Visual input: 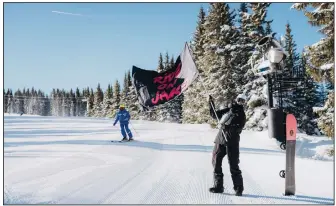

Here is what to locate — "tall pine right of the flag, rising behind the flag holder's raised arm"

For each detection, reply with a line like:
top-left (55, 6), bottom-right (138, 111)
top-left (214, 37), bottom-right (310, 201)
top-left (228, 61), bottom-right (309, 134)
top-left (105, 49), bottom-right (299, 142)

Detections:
top-left (201, 3), bottom-right (239, 126)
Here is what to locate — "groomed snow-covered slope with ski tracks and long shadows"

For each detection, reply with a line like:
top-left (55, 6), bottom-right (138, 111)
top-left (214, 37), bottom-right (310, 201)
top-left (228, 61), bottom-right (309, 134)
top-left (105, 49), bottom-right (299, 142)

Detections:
top-left (4, 115), bottom-right (334, 204)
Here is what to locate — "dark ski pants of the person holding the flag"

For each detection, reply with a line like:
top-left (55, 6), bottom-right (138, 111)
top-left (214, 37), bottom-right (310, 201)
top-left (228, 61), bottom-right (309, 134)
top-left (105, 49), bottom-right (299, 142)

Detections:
top-left (212, 141), bottom-right (244, 190)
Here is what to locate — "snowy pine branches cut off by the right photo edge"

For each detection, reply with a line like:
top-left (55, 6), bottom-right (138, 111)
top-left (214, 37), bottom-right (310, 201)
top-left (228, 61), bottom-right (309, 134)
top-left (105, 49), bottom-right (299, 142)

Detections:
top-left (292, 2), bottom-right (335, 138)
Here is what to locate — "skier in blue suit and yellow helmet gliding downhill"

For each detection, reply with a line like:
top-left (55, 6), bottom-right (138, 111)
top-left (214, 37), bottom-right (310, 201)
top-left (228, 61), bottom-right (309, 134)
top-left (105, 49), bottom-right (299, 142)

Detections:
top-left (113, 104), bottom-right (133, 141)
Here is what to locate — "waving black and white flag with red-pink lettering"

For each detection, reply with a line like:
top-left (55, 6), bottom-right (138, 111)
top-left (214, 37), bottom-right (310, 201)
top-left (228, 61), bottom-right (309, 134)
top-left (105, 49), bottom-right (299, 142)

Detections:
top-left (132, 43), bottom-right (198, 110)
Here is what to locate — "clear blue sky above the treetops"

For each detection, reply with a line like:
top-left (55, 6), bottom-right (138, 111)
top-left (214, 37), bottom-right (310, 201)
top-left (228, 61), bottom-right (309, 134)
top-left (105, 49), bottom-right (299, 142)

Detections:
top-left (4, 3), bottom-right (322, 94)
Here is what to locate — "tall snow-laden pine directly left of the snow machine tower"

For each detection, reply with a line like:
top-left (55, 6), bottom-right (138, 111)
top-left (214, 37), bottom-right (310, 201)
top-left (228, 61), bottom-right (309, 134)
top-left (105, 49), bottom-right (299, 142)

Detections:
top-left (240, 3), bottom-right (271, 131)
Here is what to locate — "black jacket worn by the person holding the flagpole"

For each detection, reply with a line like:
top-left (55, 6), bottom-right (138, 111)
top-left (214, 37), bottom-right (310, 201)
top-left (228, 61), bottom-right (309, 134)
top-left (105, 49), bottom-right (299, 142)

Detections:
top-left (209, 99), bottom-right (246, 144)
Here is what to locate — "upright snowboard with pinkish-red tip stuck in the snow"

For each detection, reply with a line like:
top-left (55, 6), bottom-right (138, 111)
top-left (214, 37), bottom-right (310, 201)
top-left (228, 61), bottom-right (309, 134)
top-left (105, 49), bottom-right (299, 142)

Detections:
top-left (283, 114), bottom-right (297, 196)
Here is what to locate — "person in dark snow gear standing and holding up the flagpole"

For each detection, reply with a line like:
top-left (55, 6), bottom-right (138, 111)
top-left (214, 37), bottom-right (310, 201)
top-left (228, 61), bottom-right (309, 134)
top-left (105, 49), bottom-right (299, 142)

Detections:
top-left (209, 94), bottom-right (246, 196)
